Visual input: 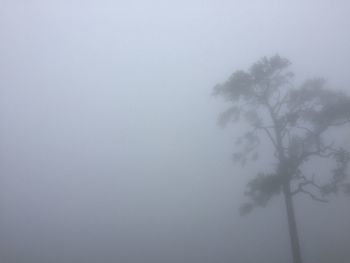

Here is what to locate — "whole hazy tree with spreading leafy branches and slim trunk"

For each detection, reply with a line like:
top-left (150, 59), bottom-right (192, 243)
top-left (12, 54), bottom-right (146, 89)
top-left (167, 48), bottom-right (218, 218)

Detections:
top-left (213, 55), bottom-right (350, 263)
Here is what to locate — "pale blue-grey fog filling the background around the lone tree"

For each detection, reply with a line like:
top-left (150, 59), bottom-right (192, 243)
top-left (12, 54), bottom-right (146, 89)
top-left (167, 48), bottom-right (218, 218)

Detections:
top-left (0, 0), bottom-right (350, 263)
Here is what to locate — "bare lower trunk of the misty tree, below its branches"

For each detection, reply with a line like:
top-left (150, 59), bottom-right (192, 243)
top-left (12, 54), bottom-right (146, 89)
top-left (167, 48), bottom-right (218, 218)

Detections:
top-left (283, 182), bottom-right (302, 263)
